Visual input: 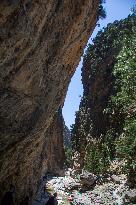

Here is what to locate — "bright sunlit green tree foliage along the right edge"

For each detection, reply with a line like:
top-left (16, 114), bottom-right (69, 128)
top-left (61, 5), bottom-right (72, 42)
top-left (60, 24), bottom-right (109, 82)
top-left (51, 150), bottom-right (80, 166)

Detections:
top-left (112, 33), bottom-right (136, 181)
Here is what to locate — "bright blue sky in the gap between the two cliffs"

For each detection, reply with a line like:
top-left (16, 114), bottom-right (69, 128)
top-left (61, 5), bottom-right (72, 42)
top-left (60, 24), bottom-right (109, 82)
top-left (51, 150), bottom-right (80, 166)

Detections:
top-left (63, 0), bottom-right (136, 128)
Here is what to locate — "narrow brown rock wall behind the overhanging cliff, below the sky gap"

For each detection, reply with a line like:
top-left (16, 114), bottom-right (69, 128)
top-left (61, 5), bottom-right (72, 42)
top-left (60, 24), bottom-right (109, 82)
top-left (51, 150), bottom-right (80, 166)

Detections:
top-left (43, 109), bottom-right (65, 175)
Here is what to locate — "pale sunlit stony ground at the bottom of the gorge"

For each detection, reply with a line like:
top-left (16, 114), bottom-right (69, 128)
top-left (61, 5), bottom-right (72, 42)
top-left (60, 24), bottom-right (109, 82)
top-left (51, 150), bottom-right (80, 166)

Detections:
top-left (33, 171), bottom-right (136, 205)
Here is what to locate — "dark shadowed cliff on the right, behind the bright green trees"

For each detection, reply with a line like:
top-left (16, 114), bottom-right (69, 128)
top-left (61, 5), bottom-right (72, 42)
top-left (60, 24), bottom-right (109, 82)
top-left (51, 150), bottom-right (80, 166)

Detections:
top-left (72, 16), bottom-right (136, 172)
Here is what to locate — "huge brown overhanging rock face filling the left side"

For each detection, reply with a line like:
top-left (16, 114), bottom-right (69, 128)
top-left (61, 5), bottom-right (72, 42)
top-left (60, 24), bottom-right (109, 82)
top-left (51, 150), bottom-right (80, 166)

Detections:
top-left (0, 0), bottom-right (99, 202)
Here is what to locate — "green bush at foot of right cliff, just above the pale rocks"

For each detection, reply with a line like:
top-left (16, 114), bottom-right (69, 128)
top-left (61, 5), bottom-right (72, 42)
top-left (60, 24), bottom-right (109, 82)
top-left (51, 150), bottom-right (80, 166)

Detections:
top-left (85, 129), bottom-right (118, 174)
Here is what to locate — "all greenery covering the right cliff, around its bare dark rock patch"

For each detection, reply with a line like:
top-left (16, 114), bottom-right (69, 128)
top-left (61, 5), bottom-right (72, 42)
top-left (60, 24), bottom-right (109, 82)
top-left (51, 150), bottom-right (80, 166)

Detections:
top-left (72, 13), bottom-right (136, 179)
